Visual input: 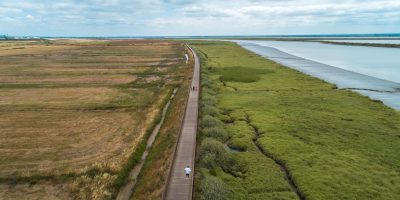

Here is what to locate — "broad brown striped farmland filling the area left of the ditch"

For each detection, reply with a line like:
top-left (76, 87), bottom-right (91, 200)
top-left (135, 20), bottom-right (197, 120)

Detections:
top-left (0, 40), bottom-right (187, 199)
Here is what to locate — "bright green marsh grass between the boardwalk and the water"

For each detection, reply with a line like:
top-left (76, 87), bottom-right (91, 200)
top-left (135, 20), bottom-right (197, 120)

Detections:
top-left (192, 42), bottom-right (400, 199)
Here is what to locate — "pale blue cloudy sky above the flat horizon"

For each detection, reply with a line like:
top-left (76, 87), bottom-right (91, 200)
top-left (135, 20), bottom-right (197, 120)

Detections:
top-left (0, 0), bottom-right (400, 36)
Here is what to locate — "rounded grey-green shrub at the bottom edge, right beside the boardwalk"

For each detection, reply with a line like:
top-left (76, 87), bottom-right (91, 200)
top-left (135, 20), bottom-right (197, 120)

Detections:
top-left (200, 176), bottom-right (229, 200)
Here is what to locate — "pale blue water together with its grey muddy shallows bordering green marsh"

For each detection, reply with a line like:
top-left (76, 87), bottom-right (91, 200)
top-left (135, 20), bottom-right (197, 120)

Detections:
top-left (235, 40), bottom-right (400, 110)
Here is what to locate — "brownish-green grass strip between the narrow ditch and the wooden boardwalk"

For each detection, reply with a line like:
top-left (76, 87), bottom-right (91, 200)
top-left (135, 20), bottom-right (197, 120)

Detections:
top-left (131, 47), bottom-right (192, 200)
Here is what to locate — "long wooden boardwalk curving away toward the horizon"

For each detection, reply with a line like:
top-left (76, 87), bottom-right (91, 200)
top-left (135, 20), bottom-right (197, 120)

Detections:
top-left (165, 47), bottom-right (200, 200)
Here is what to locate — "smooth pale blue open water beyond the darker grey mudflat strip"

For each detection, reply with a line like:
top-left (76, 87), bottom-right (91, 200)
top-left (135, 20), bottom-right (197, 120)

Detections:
top-left (239, 41), bottom-right (400, 83)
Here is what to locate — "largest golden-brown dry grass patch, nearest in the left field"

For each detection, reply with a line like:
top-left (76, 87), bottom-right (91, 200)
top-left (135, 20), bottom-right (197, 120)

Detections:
top-left (0, 110), bottom-right (144, 177)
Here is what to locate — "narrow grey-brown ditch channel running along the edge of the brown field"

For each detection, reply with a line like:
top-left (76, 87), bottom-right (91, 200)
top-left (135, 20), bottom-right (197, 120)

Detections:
top-left (117, 89), bottom-right (178, 200)
